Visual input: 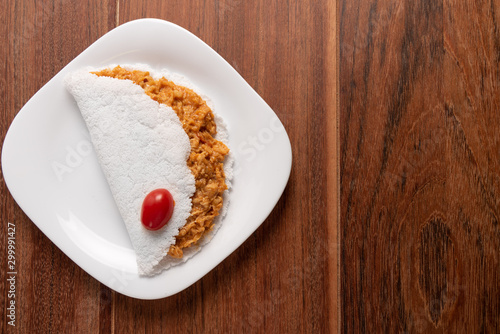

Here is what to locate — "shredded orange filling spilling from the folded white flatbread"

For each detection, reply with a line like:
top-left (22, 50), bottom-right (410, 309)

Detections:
top-left (93, 66), bottom-right (229, 258)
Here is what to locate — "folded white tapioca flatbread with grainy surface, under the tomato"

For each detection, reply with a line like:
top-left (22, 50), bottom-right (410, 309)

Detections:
top-left (66, 66), bottom-right (232, 275)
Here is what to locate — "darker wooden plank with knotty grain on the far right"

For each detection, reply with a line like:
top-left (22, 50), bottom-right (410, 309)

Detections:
top-left (339, 0), bottom-right (500, 333)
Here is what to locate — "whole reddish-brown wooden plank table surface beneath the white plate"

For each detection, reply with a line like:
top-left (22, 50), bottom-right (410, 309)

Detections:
top-left (0, 0), bottom-right (500, 333)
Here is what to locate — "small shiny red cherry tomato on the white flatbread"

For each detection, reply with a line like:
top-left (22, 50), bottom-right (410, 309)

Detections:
top-left (141, 189), bottom-right (175, 231)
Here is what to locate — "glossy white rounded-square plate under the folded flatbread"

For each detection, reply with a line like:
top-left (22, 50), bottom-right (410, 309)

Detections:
top-left (2, 19), bottom-right (292, 299)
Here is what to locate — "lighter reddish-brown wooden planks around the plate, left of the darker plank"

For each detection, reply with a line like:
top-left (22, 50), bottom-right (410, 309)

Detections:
top-left (0, 0), bottom-right (338, 333)
